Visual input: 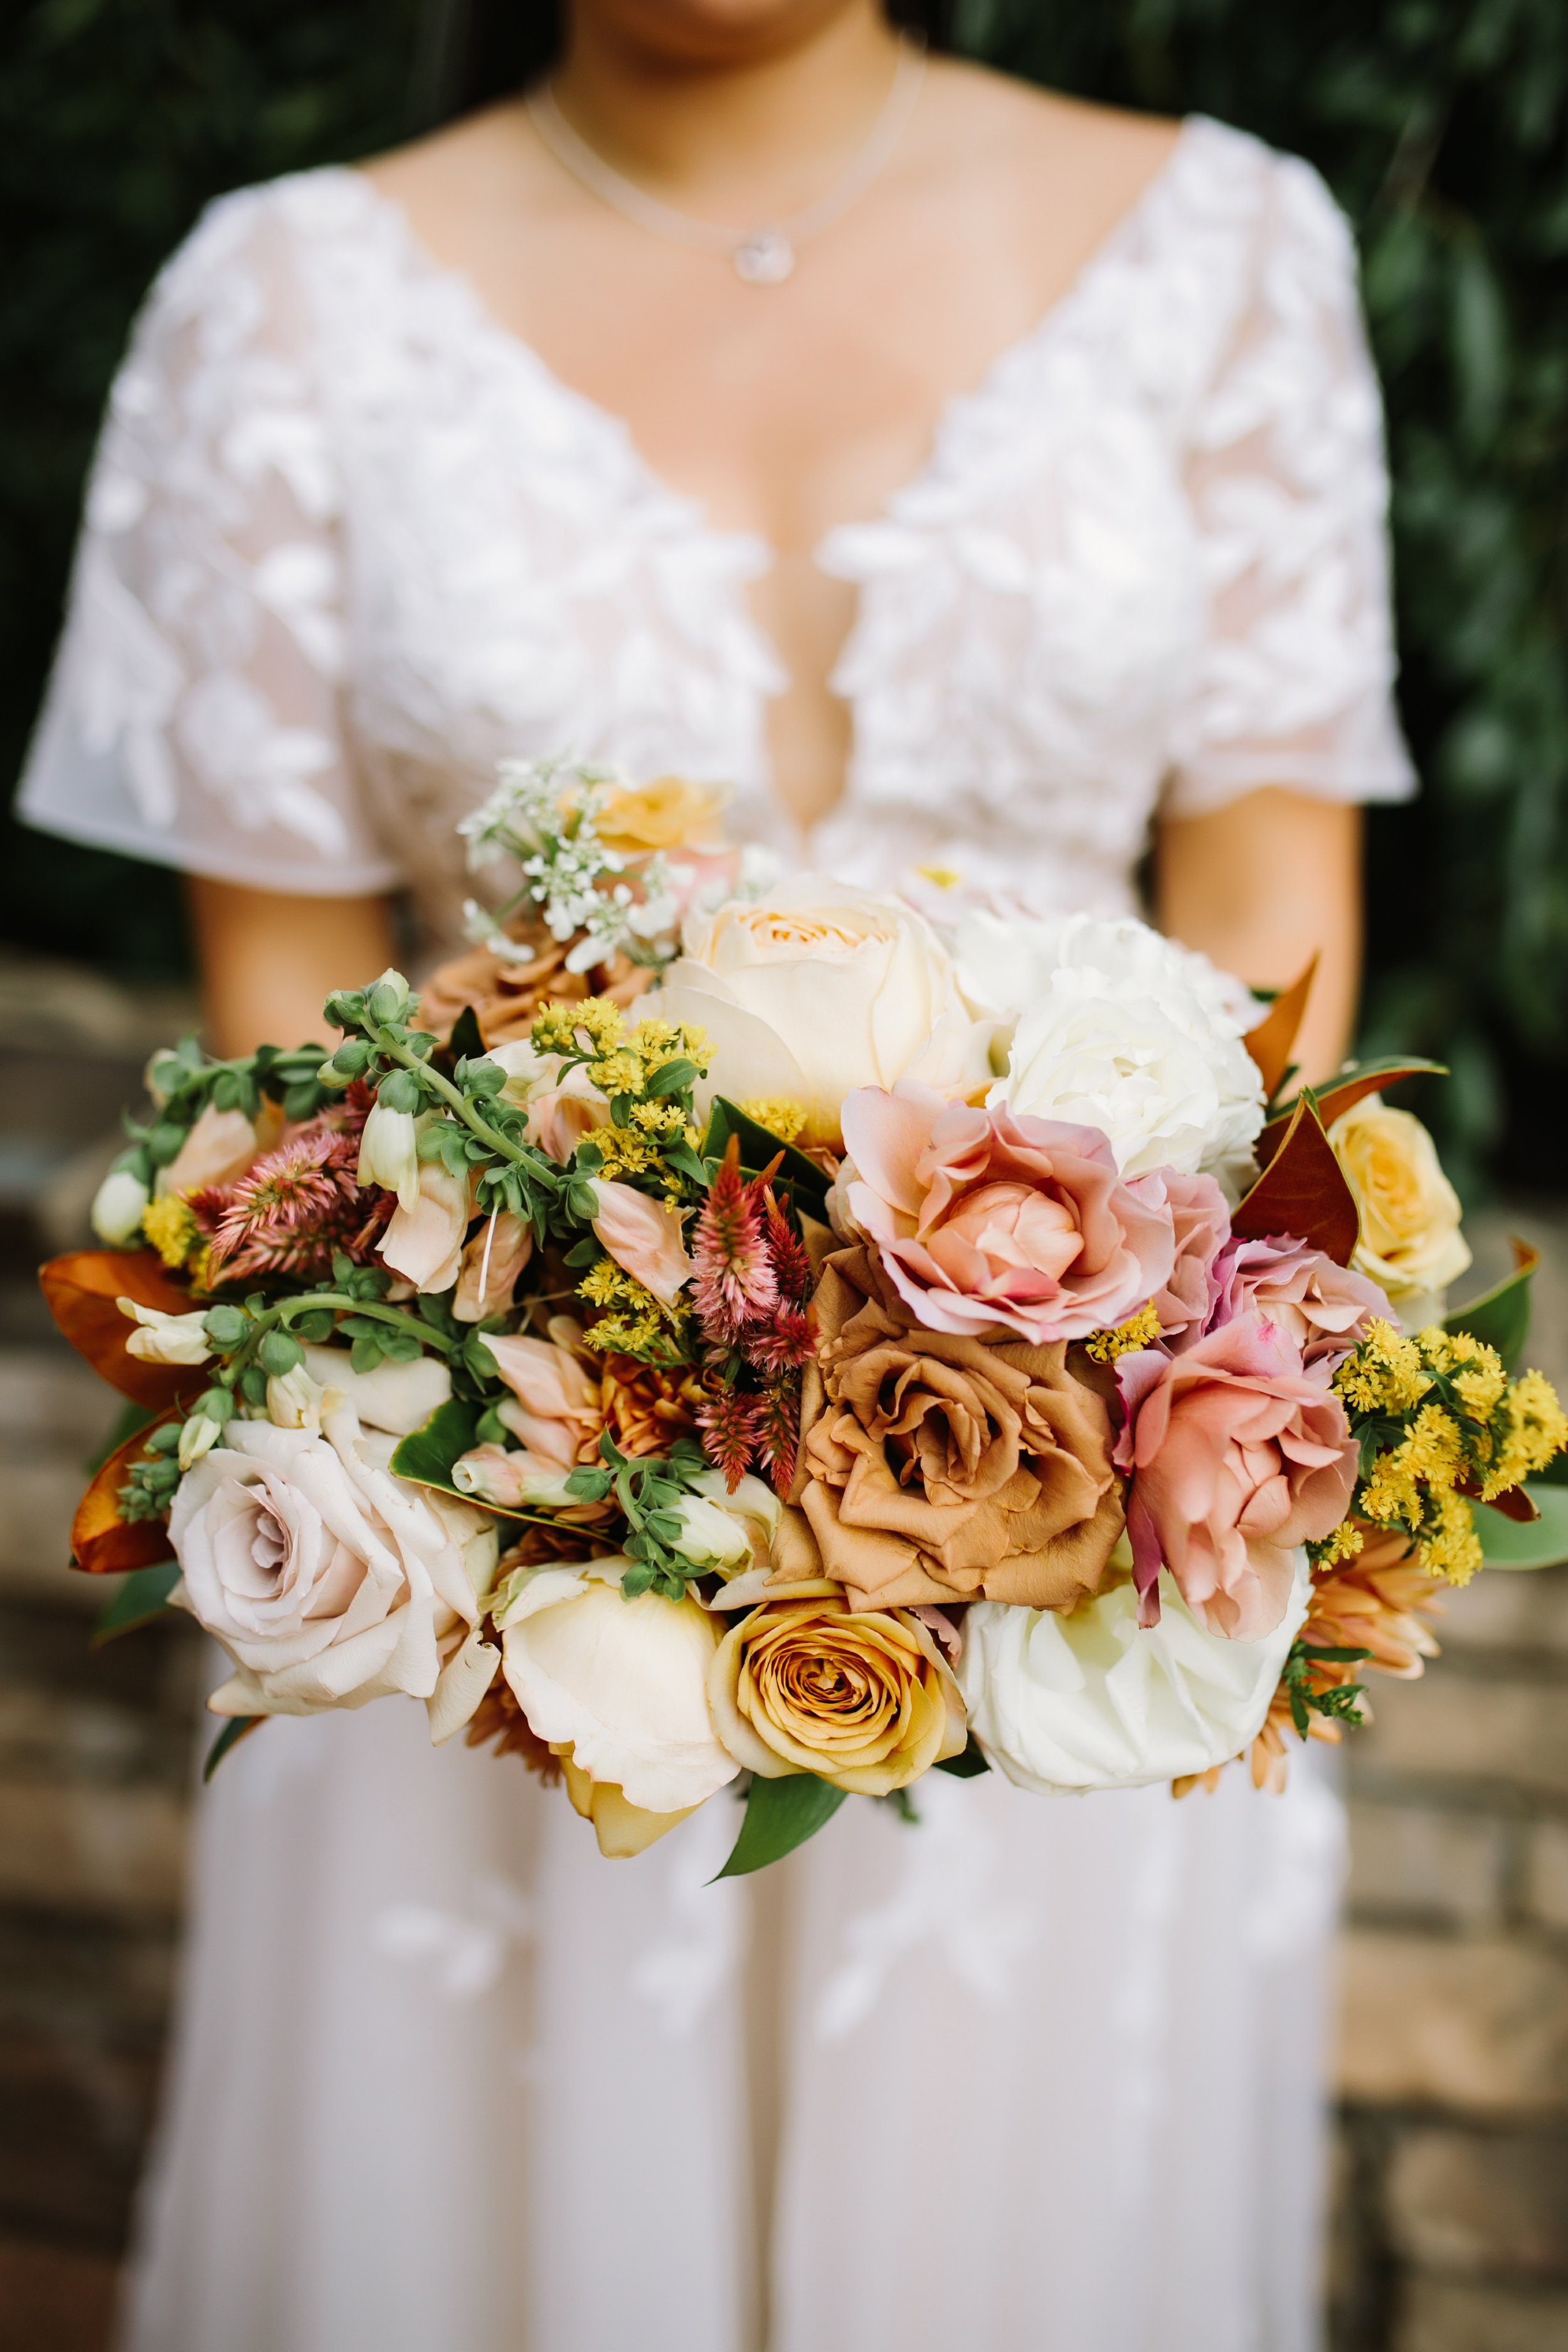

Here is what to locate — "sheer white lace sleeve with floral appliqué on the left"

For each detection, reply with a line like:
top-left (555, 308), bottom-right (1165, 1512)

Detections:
top-left (19, 191), bottom-right (400, 896)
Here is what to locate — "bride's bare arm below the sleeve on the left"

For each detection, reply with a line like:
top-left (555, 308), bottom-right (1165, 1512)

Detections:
top-left (188, 875), bottom-right (397, 1054)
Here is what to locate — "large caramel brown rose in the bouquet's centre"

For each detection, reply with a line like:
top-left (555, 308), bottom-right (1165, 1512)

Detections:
top-left (792, 1247), bottom-right (1124, 1609)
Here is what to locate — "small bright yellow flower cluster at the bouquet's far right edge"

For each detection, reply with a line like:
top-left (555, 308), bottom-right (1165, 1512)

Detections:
top-left (1314, 1322), bottom-right (1568, 1586)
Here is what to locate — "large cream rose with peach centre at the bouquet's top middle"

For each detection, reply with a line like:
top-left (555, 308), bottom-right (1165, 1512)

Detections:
top-left (658, 875), bottom-right (992, 1143)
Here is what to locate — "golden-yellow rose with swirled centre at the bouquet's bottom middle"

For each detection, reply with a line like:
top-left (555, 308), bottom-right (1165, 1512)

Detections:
top-left (707, 1578), bottom-right (968, 1797)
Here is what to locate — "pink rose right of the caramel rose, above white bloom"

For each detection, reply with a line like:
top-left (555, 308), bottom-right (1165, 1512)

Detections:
top-left (1116, 1315), bottom-right (1357, 1642)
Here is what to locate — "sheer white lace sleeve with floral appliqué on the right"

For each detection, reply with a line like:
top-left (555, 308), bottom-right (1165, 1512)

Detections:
top-left (1163, 157), bottom-right (1415, 816)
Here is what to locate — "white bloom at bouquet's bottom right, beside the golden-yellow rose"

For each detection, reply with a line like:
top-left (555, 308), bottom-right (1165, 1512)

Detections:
top-left (956, 1552), bottom-right (1311, 1794)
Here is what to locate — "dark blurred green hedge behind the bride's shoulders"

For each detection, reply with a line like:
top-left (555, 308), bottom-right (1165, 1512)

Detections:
top-left (0, 0), bottom-right (1568, 1190)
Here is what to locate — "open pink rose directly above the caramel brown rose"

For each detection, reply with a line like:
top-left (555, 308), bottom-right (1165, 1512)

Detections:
top-left (839, 1079), bottom-right (1175, 1348)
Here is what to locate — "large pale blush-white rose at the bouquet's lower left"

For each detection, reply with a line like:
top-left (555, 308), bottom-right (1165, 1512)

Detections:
top-left (169, 1392), bottom-right (496, 1715)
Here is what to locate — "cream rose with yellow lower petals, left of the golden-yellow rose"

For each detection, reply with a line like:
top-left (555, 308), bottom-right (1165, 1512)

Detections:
top-left (496, 1559), bottom-right (738, 1853)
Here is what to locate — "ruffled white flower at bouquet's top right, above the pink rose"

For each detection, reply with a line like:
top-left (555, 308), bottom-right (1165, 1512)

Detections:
top-left (956, 913), bottom-right (1264, 1200)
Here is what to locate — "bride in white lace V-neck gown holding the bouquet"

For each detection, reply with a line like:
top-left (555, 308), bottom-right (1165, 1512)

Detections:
top-left (23, 0), bottom-right (1411, 2352)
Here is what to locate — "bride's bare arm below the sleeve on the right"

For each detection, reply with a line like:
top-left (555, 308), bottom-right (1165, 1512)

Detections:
top-left (1154, 786), bottom-right (1361, 1079)
